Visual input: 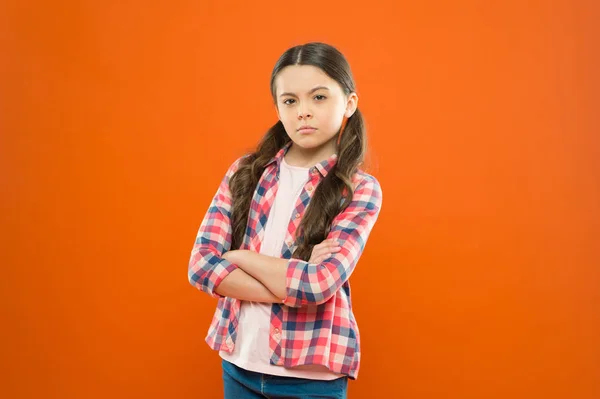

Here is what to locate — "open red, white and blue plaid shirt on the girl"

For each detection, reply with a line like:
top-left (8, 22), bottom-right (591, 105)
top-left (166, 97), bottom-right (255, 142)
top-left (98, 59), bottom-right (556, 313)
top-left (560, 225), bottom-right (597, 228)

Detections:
top-left (188, 142), bottom-right (382, 379)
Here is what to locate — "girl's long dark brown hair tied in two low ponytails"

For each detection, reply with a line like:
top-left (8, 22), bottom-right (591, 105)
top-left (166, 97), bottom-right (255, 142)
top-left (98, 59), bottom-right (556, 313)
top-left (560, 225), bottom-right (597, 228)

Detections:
top-left (229, 43), bottom-right (367, 261)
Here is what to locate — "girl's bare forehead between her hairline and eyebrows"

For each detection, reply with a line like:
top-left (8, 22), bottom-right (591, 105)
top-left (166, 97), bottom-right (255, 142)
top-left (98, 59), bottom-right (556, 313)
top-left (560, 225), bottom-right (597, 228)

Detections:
top-left (275, 65), bottom-right (341, 95)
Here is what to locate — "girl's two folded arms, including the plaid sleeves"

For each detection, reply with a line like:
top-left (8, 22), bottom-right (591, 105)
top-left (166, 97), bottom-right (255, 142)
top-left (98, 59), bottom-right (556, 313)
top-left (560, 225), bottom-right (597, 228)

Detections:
top-left (188, 158), bottom-right (382, 307)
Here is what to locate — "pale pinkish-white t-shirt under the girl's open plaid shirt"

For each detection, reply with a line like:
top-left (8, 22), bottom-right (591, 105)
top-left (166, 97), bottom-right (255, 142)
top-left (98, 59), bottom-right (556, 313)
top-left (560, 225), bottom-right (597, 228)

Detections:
top-left (219, 158), bottom-right (343, 380)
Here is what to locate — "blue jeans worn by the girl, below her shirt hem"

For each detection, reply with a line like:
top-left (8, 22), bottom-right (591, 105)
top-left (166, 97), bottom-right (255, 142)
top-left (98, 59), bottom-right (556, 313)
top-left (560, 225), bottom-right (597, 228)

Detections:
top-left (222, 360), bottom-right (348, 399)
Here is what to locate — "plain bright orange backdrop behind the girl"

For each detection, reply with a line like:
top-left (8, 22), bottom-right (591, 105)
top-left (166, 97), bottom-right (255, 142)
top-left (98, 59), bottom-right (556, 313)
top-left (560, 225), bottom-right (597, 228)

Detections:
top-left (0, 0), bottom-right (600, 399)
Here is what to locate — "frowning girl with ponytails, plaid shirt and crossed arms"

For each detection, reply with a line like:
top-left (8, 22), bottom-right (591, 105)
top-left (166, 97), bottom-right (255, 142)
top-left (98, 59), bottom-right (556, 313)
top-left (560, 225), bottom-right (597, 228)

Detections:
top-left (188, 43), bottom-right (382, 399)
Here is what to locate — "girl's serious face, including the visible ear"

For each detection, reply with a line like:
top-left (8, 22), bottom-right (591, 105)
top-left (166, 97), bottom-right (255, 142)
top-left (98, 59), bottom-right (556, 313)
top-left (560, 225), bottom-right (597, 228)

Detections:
top-left (275, 65), bottom-right (358, 149)
